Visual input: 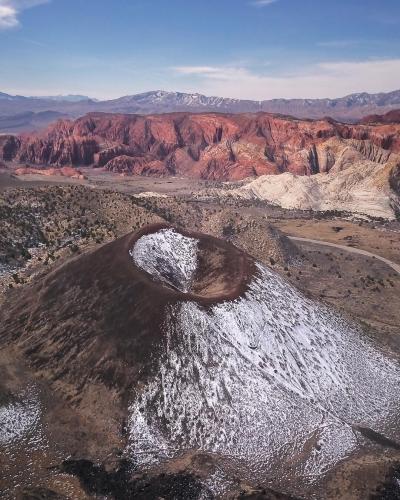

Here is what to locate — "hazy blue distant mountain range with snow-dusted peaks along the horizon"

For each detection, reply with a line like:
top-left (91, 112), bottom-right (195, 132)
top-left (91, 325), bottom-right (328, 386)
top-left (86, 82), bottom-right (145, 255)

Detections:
top-left (0, 90), bottom-right (400, 133)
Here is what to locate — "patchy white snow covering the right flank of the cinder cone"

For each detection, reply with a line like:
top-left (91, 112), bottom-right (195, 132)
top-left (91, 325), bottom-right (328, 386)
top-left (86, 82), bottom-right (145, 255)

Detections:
top-left (129, 233), bottom-right (400, 490)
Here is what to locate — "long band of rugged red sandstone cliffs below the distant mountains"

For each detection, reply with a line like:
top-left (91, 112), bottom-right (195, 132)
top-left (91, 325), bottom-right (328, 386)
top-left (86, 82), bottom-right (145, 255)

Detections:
top-left (0, 113), bottom-right (400, 180)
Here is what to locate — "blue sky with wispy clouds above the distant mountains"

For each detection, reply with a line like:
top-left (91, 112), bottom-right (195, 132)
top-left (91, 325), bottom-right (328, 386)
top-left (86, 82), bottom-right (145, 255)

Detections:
top-left (0, 0), bottom-right (400, 99)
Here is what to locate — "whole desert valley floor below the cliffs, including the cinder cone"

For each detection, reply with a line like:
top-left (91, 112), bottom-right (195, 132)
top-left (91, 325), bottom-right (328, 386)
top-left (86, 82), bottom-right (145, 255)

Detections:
top-left (0, 168), bottom-right (400, 500)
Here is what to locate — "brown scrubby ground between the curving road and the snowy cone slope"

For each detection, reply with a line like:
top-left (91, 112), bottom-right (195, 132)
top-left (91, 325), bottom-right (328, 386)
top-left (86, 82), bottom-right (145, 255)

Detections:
top-left (287, 241), bottom-right (400, 353)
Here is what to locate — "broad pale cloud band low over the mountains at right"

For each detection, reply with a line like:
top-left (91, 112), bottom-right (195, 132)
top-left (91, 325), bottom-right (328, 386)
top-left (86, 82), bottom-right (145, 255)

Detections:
top-left (174, 59), bottom-right (400, 100)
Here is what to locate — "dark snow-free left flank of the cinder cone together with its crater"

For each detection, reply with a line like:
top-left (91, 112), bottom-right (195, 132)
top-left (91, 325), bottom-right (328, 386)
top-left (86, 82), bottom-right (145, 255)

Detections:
top-left (0, 224), bottom-right (255, 401)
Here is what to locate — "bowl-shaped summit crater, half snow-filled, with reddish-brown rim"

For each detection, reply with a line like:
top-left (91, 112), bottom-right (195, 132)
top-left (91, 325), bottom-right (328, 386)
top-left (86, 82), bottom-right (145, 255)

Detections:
top-left (129, 225), bottom-right (256, 304)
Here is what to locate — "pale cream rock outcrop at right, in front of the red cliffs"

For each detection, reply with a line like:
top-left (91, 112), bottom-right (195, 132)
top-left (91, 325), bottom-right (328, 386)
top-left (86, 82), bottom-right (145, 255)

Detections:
top-left (203, 138), bottom-right (400, 219)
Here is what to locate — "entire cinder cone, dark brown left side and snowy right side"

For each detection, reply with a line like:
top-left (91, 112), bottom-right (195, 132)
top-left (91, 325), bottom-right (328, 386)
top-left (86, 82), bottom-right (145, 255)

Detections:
top-left (0, 224), bottom-right (400, 495)
